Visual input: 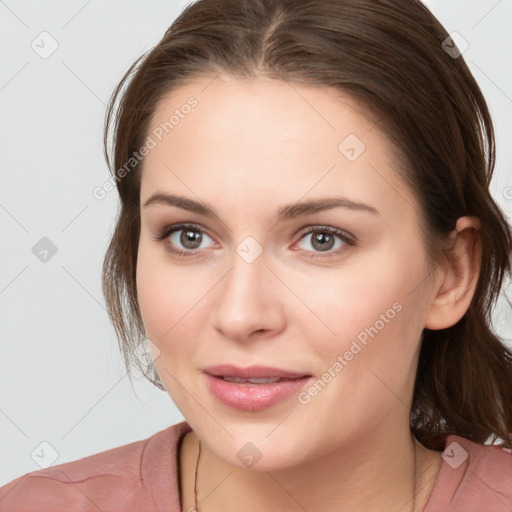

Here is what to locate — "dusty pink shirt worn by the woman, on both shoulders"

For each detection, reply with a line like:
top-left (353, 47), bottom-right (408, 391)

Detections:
top-left (0, 421), bottom-right (512, 512)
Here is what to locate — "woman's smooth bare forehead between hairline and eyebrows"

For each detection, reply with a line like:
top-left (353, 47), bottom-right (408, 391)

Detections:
top-left (141, 77), bottom-right (414, 220)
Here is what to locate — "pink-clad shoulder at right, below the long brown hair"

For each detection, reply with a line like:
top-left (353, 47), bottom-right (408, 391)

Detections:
top-left (424, 435), bottom-right (512, 512)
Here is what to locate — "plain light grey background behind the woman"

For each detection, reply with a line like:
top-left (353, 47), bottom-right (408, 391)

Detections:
top-left (0, 0), bottom-right (512, 485)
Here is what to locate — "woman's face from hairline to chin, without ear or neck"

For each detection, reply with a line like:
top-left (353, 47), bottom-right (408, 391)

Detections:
top-left (137, 77), bottom-right (435, 470)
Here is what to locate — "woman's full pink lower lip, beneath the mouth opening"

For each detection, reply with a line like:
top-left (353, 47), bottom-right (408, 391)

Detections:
top-left (205, 374), bottom-right (313, 411)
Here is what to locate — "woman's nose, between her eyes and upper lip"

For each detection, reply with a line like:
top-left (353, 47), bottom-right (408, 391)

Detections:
top-left (210, 244), bottom-right (286, 342)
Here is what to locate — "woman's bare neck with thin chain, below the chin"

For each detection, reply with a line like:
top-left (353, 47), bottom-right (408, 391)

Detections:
top-left (180, 420), bottom-right (441, 512)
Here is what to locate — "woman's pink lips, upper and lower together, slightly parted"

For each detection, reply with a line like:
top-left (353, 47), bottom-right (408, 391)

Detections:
top-left (204, 365), bottom-right (313, 412)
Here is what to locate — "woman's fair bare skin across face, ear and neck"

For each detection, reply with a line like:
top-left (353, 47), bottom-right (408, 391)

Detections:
top-left (137, 76), bottom-right (480, 512)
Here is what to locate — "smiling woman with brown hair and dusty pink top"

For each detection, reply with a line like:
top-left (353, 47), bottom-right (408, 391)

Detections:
top-left (0, 0), bottom-right (512, 512)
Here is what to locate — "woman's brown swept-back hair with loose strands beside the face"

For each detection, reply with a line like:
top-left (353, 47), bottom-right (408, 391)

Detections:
top-left (102, 0), bottom-right (512, 449)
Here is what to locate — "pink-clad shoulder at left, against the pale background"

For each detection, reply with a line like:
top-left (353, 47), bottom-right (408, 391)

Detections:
top-left (0, 422), bottom-right (190, 512)
